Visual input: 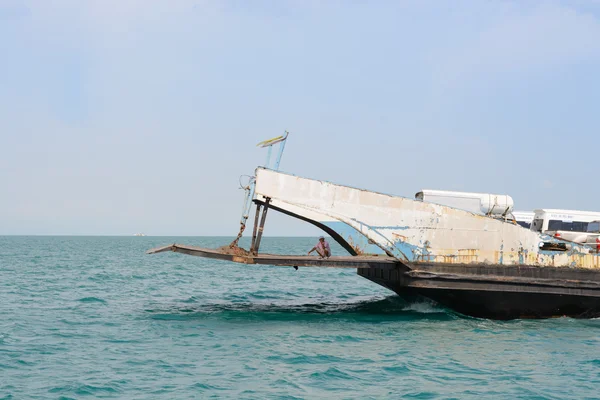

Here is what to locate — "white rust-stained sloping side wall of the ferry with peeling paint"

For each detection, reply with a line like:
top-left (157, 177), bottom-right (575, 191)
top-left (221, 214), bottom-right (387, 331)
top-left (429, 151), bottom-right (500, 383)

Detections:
top-left (256, 168), bottom-right (600, 269)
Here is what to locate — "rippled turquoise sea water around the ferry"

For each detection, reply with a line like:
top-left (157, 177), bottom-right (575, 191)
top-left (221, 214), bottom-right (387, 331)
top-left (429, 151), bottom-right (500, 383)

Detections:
top-left (0, 237), bottom-right (600, 399)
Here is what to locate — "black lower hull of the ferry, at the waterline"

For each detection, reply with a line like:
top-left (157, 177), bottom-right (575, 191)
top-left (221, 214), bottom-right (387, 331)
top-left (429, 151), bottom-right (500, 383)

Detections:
top-left (358, 265), bottom-right (600, 320)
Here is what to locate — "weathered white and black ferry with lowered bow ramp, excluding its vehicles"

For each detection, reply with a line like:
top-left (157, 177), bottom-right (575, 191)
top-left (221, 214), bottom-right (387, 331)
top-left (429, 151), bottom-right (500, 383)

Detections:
top-left (148, 133), bottom-right (600, 319)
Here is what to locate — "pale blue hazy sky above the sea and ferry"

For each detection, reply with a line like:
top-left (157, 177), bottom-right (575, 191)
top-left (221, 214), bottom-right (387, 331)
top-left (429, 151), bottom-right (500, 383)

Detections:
top-left (0, 0), bottom-right (600, 236)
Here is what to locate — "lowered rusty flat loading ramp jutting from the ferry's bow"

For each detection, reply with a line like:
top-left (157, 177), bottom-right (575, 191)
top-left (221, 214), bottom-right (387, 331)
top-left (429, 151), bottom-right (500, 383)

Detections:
top-left (146, 244), bottom-right (403, 269)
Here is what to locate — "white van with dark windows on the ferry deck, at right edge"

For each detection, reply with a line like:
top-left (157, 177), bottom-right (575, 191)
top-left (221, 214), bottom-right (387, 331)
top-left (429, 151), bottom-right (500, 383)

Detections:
top-left (531, 209), bottom-right (600, 243)
